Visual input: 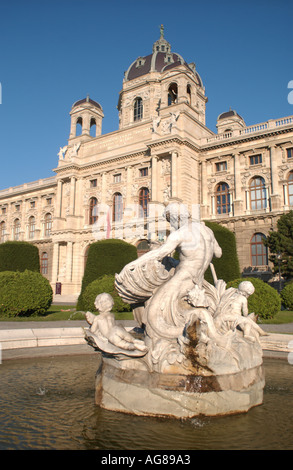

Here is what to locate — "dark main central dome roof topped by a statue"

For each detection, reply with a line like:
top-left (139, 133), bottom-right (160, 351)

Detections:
top-left (124, 25), bottom-right (203, 88)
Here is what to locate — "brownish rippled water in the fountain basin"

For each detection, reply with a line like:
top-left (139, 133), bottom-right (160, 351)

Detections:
top-left (0, 353), bottom-right (293, 450)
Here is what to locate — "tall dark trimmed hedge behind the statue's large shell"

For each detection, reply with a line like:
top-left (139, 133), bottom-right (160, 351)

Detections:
top-left (77, 239), bottom-right (137, 310)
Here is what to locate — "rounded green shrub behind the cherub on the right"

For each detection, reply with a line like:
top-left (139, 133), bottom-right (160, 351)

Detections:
top-left (227, 277), bottom-right (281, 319)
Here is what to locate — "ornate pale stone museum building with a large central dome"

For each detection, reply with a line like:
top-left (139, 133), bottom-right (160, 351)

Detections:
top-left (0, 28), bottom-right (293, 295)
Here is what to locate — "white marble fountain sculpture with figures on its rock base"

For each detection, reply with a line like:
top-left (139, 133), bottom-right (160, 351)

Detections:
top-left (85, 203), bottom-right (266, 418)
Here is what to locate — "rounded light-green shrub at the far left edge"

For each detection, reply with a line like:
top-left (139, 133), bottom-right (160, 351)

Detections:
top-left (0, 270), bottom-right (53, 317)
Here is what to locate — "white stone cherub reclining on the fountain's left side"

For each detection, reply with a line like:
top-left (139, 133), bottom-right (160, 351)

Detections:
top-left (85, 292), bottom-right (147, 351)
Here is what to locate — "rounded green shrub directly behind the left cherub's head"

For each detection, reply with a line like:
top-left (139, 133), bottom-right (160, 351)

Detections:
top-left (82, 274), bottom-right (131, 312)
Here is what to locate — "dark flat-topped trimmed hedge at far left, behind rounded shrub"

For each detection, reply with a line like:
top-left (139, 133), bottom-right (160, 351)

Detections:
top-left (0, 241), bottom-right (40, 272)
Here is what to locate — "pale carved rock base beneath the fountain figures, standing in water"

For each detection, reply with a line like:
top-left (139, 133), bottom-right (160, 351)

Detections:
top-left (95, 358), bottom-right (265, 418)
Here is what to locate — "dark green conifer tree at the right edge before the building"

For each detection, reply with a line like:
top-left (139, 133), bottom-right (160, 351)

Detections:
top-left (263, 211), bottom-right (293, 278)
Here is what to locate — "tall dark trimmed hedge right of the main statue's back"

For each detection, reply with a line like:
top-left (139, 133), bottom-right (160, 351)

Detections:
top-left (205, 221), bottom-right (240, 284)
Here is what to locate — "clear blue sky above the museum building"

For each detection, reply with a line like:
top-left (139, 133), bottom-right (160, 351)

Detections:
top-left (0, 0), bottom-right (293, 189)
